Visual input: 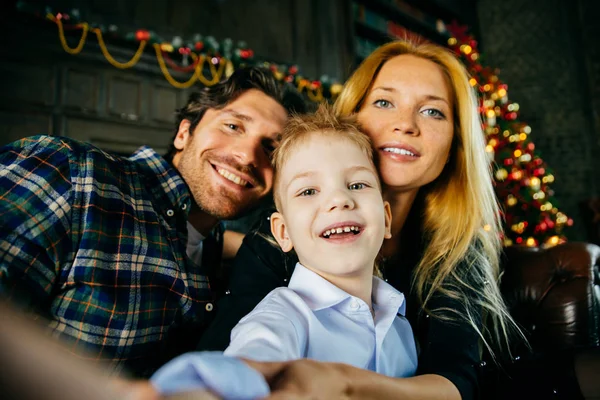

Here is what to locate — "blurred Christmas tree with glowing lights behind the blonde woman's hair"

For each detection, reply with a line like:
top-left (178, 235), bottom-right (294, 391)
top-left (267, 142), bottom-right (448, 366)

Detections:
top-left (447, 24), bottom-right (573, 247)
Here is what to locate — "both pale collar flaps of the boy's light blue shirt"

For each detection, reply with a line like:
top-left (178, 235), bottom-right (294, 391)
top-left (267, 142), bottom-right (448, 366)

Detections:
top-left (288, 263), bottom-right (406, 315)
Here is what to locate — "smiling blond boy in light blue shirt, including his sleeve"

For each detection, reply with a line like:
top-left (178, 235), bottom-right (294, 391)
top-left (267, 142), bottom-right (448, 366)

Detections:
top-left (152, 107), bottom-right (417, 398)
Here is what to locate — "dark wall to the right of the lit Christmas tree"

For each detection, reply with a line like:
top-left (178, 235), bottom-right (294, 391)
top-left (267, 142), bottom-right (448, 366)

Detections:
top-left (478, 0), bottom-right (600, 240)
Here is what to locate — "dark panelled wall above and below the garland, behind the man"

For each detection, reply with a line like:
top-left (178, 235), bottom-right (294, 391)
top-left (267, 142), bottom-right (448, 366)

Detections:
top-left (0, 0), bottom-right (351, 153)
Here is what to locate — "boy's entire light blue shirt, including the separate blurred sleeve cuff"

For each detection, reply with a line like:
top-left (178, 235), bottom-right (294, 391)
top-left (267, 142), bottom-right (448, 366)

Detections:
top-left (151, 264), bottom-right (417, 399)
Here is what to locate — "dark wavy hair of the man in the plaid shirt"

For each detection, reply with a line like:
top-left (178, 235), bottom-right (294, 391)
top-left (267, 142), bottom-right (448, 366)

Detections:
top-left (164, 67), bottom-right (306, 163)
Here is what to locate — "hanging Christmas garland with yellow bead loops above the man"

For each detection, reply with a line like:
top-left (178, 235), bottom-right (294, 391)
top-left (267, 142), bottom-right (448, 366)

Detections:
top-left (17, 1), bottom-right (342, 102)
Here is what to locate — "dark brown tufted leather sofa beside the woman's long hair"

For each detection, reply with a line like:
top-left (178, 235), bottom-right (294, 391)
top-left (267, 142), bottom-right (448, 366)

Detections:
top-left (481, 243), bottom-right (600, 400)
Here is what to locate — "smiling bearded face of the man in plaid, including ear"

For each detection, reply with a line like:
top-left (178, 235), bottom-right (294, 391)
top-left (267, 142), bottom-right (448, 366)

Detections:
top-left (173, 89), bottom-right (287, 219)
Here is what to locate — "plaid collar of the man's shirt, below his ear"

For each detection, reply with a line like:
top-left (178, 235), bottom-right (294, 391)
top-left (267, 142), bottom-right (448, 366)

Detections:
top-left (129, 146), bottom-right (191, 213)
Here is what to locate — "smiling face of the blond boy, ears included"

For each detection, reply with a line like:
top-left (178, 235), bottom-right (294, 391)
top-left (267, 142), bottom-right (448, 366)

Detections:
top-left (271, 132), bottom-right (391, 279)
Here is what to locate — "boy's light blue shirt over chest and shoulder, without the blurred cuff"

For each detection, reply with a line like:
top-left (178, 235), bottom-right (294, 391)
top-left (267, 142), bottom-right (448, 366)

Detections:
top-left (225, 263), bottom-right (417, 377)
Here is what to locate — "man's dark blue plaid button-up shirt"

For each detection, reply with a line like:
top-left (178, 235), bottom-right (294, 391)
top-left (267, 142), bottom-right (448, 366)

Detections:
top-left (0, 136), bottom-right (213, 376)
